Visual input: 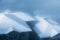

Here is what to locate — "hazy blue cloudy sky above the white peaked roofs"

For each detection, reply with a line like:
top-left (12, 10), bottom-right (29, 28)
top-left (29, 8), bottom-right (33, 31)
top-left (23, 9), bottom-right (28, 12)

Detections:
top-left (0, 0), bottom-right (60, 22)
